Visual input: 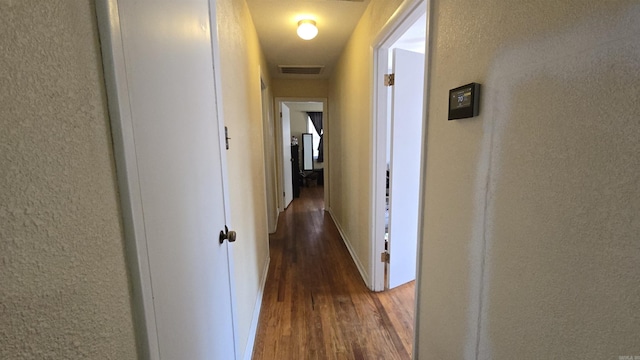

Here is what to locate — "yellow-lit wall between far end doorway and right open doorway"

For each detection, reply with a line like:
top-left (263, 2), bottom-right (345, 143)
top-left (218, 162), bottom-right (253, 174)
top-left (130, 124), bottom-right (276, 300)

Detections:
top-left (326, 0), bottom-right (402, 282)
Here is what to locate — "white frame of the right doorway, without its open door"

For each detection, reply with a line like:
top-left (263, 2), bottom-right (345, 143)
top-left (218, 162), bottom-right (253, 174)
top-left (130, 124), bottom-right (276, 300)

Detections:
top-left (369, 0), bottom-right (429, 291)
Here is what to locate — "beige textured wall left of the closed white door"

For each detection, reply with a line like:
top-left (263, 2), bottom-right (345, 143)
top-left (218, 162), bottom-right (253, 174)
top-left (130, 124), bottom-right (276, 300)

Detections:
top-left (0, 0), bottom-right (136, 359)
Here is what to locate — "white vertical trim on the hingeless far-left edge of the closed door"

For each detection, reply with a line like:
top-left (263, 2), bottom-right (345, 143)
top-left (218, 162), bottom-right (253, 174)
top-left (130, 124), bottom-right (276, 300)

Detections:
top-left (96, 0), bottom-right (160, 359)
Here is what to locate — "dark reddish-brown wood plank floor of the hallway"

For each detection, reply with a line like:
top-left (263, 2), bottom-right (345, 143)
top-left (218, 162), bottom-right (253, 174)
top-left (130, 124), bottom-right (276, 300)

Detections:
top-left (253, 187), bottom-right (414, 360)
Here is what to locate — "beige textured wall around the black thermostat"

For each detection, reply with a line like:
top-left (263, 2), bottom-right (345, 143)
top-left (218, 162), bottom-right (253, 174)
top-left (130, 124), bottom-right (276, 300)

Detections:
top-left (418, 0), bottom-right (640, 359)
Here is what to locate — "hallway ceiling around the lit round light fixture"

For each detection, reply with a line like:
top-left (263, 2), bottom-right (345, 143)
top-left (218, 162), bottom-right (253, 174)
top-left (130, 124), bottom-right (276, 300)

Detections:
top-left (247, 0), bottom-right (376, 79)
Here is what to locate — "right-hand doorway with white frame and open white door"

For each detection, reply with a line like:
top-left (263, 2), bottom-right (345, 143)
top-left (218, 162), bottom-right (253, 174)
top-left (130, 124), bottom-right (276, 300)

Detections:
top-left (371, 1), bottom-right (427, 291)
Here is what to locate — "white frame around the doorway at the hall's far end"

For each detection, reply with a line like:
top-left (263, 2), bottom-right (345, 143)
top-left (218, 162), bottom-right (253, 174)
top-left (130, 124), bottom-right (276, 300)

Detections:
top-left (274, 97), bottom-right (331, 211)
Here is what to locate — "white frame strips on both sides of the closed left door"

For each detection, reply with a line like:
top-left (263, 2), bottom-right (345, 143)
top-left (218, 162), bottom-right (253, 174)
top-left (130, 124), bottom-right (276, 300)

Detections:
top-left (96, 0), bottom-right (239, 359)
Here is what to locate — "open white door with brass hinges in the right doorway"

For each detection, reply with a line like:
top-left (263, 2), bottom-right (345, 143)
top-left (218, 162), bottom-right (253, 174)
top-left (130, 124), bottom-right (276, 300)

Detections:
top-left (389, 49), bottom-right (424, 288)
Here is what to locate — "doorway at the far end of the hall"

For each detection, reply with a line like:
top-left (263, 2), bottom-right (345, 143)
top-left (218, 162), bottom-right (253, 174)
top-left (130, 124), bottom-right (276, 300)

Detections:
top-left (275, 98), bottom-right (329, 212)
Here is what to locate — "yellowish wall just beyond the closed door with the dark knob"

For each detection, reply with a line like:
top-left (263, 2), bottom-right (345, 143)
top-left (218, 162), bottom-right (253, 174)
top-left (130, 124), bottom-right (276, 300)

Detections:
top-left (217, 0), bottom-right (269, 359)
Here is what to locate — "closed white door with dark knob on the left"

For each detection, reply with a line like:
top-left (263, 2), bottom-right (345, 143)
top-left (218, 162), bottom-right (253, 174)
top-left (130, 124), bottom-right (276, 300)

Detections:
top-left (118, 0), bottom-right (235, 360)
